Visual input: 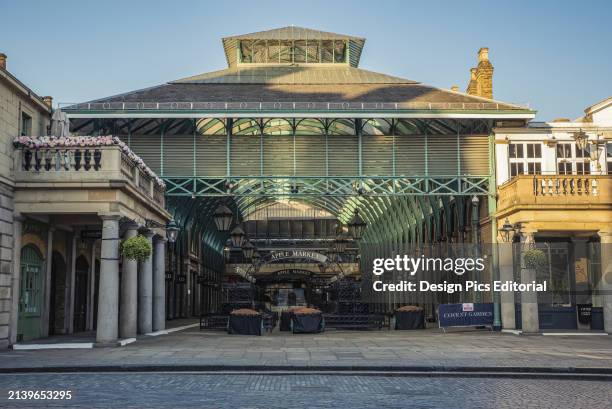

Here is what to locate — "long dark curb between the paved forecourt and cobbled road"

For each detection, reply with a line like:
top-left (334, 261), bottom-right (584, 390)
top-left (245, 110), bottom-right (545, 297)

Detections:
top-left (0, 365), bottom-right (612, 381)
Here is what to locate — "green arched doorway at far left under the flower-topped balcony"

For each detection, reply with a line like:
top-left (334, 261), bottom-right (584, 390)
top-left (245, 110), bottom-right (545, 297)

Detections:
top-left (17, 245), bottom-right (44, 341)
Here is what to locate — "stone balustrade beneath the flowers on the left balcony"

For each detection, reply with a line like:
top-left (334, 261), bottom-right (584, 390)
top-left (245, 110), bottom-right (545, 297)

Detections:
top-left (14, 146), bottom-right (165, 208)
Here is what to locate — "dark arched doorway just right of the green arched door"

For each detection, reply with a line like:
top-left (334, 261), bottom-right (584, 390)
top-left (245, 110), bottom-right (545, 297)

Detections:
top-left (49, 251), bottom-right (66, 335)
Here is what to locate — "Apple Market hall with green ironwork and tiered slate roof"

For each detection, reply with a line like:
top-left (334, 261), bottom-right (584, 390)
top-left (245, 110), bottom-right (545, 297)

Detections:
top-left (63, 26), bottom-right (534, 332)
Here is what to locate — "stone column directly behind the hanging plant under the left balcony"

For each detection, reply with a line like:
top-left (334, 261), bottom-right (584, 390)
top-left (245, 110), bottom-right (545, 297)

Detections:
top-left (119, 223), bottom-right (138, 338)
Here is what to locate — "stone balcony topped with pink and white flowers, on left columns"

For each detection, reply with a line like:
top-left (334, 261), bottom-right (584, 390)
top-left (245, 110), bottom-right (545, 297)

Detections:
top-left (14, 137), bottom-right (167, 221)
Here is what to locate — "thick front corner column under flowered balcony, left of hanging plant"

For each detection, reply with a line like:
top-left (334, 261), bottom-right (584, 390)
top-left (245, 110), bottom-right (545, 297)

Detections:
top-left (96, 215), bottom-right (120, 346)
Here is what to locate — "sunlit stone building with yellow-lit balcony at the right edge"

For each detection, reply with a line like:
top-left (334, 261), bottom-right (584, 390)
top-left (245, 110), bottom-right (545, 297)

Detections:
top-left (495, 98), bottom-right (612, 333)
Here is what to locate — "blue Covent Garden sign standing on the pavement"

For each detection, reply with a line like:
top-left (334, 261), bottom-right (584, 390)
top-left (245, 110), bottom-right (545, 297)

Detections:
top-left (438, 303), bottom-right (493, 327)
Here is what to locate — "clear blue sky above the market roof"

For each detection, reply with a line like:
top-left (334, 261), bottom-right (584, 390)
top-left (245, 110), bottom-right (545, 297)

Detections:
top-left (0, 0), bottom-right (612, 120)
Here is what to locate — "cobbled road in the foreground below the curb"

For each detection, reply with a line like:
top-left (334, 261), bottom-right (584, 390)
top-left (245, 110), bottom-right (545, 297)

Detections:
top-left (0, 373), bottom-right (612, 409)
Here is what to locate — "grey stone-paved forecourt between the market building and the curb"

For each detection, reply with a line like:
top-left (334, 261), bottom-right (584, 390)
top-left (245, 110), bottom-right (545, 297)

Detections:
top-left (0, 323), bottom-right (612, 376)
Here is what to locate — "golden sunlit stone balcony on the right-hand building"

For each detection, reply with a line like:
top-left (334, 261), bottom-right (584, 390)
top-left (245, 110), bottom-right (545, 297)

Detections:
top-left (497, 175), bottom-right (612, 213)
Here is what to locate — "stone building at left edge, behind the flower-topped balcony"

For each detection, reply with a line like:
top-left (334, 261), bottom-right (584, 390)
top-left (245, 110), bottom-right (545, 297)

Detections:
top-left (0, 53), bottom-right (52, 348)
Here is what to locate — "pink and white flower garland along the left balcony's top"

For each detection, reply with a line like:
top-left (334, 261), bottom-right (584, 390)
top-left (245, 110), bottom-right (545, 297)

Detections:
top-left (13, 135), bottom-right (166, 189)
